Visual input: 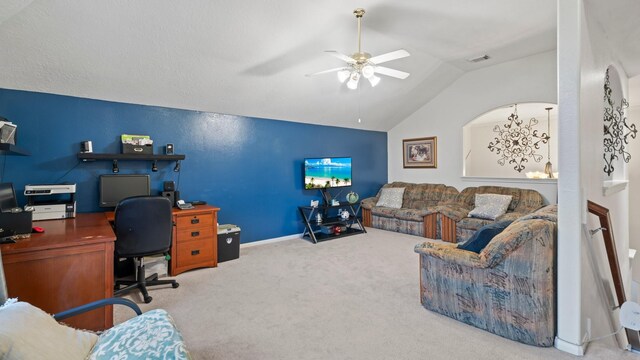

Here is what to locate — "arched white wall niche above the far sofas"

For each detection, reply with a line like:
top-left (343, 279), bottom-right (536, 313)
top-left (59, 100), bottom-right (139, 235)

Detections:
top-left (462, 102), bottom-right (559, 181)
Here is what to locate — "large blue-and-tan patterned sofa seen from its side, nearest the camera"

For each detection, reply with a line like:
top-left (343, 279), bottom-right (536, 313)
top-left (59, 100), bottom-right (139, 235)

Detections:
top-left (415, 205), bottom-right (557, 346)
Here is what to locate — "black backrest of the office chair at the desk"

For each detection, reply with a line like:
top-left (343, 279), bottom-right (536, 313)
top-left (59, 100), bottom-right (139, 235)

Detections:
top-left (114, 196), bottom-right (173, 257)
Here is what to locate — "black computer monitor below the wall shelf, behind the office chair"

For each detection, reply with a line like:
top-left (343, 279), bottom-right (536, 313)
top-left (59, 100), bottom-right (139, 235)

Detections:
top-left (100, 175), bottom-right (151, 207)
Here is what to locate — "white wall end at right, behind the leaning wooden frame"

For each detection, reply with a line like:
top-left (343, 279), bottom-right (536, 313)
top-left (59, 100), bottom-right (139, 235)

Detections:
top-left (556, 0), bottom-right (629, 355)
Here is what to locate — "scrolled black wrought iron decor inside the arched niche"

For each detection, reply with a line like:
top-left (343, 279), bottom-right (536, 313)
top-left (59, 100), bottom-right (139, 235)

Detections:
top-left (488, 104), bottom-right (550, 172)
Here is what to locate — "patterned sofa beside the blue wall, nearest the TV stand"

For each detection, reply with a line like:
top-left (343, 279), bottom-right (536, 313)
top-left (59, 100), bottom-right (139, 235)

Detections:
top-left (361, 182), bottom-right (458, 239)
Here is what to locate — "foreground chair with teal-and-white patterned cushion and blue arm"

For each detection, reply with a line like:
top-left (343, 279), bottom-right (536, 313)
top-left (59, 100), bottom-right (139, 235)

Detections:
top-left (0, 298), bottom-right (191, 360)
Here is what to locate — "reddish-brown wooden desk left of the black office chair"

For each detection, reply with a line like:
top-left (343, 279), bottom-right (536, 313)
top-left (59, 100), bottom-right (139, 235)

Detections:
top-left (0, 213), bottom-right (116, 330)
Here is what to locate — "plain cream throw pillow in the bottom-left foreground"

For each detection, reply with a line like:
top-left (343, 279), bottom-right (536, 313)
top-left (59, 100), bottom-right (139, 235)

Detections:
top-left (0, 300), bottom-right (98, 360)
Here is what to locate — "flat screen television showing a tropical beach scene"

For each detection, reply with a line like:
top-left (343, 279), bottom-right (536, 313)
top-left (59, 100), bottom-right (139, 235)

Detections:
top-left (304, 157), bottom-right (353, 190)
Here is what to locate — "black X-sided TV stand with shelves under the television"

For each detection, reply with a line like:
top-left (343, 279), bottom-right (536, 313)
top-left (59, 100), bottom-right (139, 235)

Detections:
top-left (298, 202), bottom-right (367, 244)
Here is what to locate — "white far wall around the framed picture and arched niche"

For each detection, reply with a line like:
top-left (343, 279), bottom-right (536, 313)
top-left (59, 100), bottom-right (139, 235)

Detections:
top-left (387, 51), bottom-right (557, 203)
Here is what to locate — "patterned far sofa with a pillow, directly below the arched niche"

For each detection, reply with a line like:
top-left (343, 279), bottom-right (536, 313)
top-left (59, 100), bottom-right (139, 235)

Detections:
top-left (438, 186), bottom-right (544, 242)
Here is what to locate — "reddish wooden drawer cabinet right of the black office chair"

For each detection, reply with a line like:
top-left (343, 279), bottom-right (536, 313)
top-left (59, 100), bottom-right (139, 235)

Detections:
top-left (169, 205), bottom-right (220, 276)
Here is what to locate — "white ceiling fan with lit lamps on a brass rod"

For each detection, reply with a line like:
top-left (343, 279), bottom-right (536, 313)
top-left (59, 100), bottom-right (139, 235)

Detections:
top-left (307, 8), bottom-right (410, 90)
